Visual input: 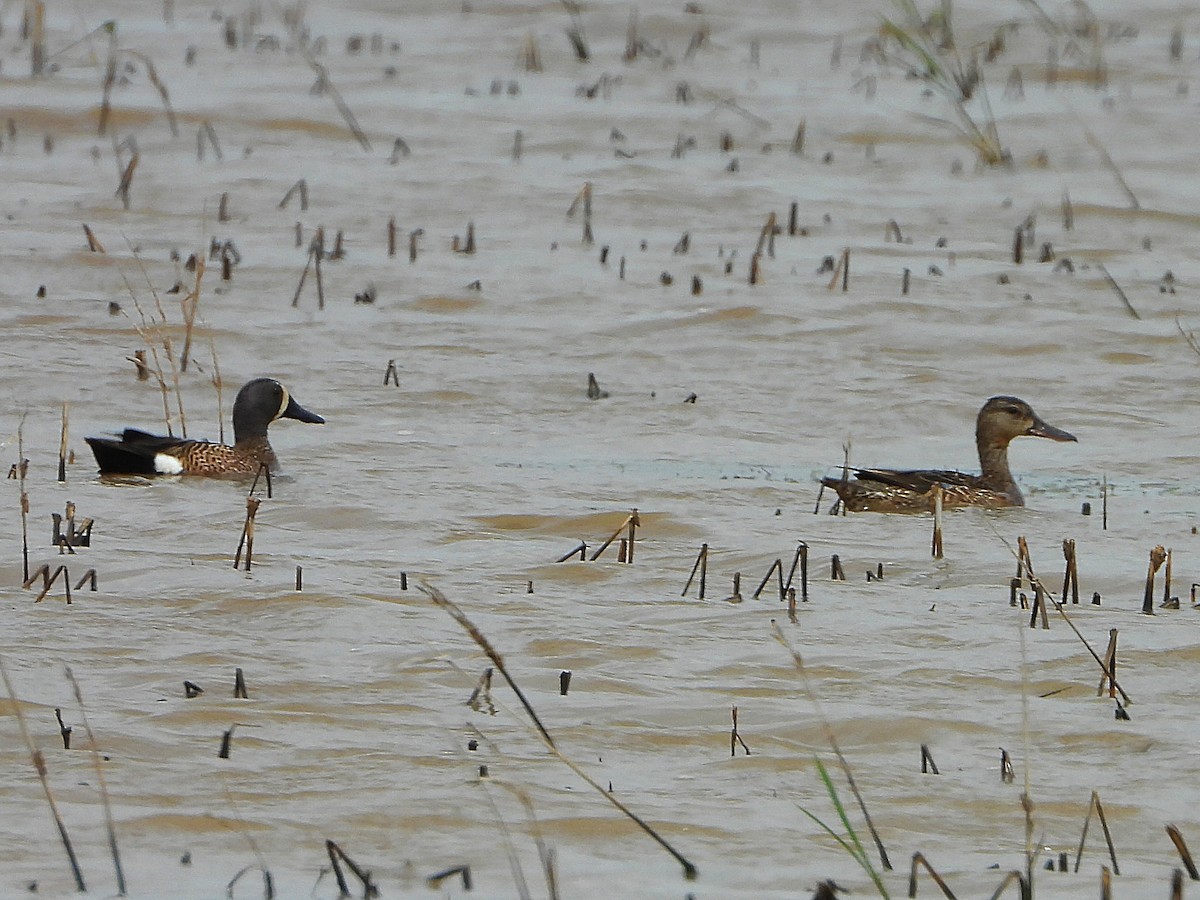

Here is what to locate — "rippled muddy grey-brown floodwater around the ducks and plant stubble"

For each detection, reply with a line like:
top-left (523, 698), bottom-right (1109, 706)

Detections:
top-left (0, 0), bottom-right (1200, 898)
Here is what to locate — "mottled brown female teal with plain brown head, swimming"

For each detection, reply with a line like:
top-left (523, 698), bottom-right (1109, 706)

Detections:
top-left (821, 397), bottom-right (1076, 512)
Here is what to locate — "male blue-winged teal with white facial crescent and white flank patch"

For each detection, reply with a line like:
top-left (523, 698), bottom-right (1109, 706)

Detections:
top-left (86, 378), bottom-right (325, 475)
